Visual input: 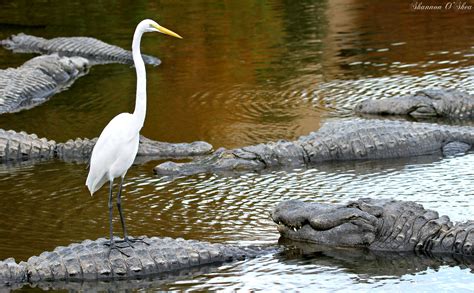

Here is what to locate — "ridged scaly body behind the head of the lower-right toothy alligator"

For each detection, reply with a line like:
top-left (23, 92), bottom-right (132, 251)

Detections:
top-left (348, 199), bottom-right (474, 256)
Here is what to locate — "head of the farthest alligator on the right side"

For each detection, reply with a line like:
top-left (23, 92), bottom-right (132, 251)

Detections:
top-left (354, 91), bottom-right (441, 118)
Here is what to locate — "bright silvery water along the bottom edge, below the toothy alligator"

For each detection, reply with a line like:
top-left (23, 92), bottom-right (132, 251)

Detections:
top-left (164, 243), bottom-right (474, 292)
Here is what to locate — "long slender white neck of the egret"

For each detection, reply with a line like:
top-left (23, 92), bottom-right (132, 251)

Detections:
top-left (132, 28), bottom-right (146, 128)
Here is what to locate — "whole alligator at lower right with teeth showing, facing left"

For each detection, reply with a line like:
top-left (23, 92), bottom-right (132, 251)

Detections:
top-left (271, 198), bottom-right (474, 253)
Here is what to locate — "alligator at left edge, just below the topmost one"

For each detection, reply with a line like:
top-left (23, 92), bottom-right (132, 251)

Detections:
top-left (0, 54), bottom-right (89, 114)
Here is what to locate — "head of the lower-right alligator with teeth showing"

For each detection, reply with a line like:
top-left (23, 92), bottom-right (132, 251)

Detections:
top-left (272, 200), bottom-right (381, 247)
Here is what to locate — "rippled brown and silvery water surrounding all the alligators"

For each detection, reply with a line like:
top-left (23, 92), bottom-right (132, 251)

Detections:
top-left (0, 0), bottom-right (474, 291)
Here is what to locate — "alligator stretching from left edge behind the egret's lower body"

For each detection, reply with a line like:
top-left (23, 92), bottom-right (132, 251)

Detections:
top-left (0, 129), bottom-right (212, 163)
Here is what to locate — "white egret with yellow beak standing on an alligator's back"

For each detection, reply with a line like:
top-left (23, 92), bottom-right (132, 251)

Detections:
top-left (86, 19), bottom-right (181, 251)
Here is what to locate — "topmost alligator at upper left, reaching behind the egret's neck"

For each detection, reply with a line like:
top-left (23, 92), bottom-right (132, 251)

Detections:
top-left (0, 33), bottom-right (161, 66)
